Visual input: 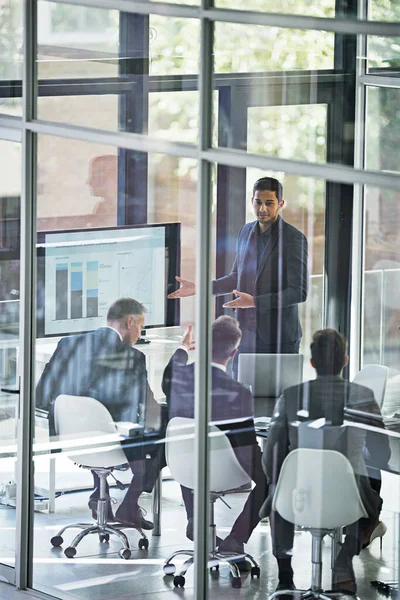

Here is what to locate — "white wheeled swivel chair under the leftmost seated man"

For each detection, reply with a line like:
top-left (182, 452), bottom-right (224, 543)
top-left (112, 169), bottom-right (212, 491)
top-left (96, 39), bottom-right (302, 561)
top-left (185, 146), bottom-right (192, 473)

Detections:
top-left (50, 394), bottom-right (149, 559)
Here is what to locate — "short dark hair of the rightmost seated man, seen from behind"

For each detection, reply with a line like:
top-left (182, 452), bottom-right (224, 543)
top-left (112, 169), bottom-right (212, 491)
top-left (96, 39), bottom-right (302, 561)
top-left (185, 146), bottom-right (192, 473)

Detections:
top-left (311, 329), bottom-right (347, 375)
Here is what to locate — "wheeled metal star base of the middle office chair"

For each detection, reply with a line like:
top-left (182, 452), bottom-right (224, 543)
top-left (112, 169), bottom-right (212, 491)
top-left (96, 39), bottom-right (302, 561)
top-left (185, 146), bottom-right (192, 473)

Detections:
top-left (163, 550), bottom-right (260, 588)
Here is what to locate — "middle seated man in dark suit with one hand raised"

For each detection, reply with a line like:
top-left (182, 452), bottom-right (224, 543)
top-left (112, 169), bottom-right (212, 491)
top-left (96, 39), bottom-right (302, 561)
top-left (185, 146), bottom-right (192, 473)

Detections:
top-left (163, 316), bottom-right (267, 568)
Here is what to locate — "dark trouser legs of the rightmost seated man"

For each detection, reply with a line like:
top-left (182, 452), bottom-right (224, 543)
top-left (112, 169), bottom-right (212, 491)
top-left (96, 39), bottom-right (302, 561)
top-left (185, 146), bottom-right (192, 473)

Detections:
top-left (270, 481), bottom-right (382, 559)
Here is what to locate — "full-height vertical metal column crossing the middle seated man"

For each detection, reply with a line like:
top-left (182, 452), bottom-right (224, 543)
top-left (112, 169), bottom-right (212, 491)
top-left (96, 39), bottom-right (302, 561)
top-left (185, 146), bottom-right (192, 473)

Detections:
top-left (194, 0), bottom-right (214, 600)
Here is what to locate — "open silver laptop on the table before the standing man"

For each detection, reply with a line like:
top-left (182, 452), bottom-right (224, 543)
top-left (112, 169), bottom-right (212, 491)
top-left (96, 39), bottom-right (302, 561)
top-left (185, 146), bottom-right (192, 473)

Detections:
top-left (238, 354), bottom-right (303, 417)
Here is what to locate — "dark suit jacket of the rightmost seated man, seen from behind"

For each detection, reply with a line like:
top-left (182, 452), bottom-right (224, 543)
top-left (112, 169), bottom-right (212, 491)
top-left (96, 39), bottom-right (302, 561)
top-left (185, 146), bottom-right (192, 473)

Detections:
top-left (260, 376), bottom-right (390, 516)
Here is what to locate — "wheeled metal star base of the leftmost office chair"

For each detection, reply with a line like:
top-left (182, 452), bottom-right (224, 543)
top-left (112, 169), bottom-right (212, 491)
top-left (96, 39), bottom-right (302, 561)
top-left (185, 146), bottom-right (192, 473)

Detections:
top-left (51, 523), bottom-right (149, 559)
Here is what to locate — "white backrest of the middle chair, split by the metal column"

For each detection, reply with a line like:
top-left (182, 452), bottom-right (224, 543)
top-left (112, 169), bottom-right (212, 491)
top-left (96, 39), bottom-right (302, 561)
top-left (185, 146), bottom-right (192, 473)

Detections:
top-left (165, 417), bottom-right (250, 493)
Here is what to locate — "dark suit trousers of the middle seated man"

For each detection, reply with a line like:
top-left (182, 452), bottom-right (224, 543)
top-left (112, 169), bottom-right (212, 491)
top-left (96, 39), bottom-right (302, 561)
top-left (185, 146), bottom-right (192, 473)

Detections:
top-left (181, 447), bottom-right (268, 544)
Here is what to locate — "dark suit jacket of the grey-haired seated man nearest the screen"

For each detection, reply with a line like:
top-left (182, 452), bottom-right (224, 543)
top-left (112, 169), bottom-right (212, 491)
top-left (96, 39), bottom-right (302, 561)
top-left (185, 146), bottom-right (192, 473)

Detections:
top-left (36, 327), bottom-right (160, 460)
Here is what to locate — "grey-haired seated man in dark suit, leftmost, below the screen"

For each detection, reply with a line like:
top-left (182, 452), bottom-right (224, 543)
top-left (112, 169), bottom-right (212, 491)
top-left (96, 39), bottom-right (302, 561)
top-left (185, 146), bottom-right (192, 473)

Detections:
top-left (36, 298), bottom-right (163, 529)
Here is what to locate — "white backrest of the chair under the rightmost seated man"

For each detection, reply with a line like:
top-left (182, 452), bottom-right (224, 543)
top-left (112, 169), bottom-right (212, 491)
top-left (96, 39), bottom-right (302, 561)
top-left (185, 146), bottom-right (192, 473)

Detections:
top-left (272, 448), bottom-right (367, 529)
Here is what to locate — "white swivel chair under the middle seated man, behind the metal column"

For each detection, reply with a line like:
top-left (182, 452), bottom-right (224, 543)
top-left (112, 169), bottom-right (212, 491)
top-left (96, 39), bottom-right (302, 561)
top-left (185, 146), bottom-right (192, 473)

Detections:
top-left (163, 417), bottom-right (260, 588)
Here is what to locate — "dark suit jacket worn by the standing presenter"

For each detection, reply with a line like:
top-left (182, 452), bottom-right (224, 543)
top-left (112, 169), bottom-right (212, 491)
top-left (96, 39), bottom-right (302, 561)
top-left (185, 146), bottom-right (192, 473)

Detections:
top-left (213, 216), bottom-right (308, 344)
